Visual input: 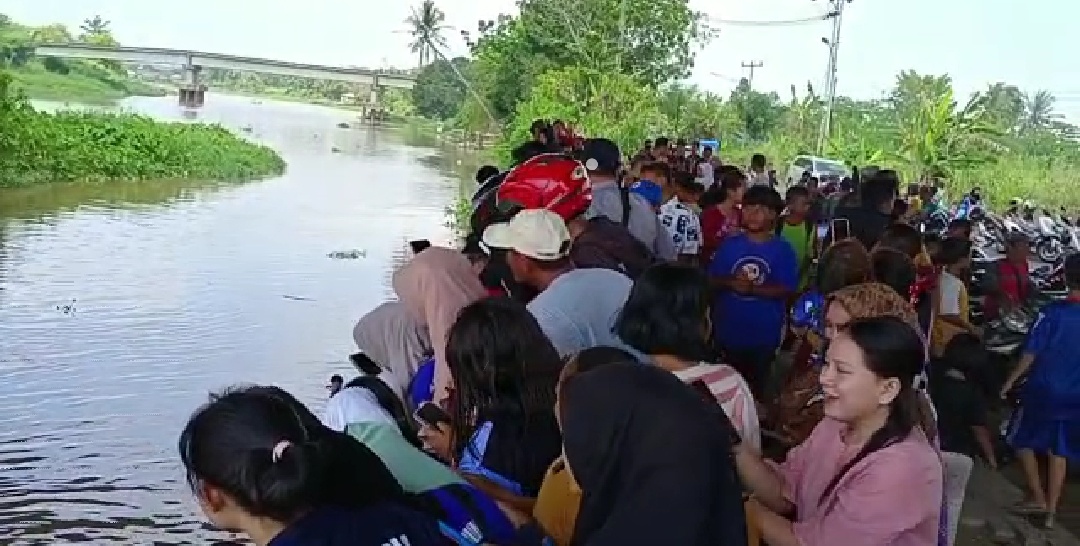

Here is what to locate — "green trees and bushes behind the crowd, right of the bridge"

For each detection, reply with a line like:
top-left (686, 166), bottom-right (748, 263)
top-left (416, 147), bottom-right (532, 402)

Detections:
top-left (406, 0), bottom-right (1080, 206)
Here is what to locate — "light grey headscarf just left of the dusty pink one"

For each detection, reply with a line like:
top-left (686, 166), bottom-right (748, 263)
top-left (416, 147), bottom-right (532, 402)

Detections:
top-left (352, 301), bottom-right (431, 396)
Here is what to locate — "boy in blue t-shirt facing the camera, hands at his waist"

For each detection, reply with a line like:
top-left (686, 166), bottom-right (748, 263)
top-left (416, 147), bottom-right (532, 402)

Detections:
top-left (708, 186), bottom-right (799, 400)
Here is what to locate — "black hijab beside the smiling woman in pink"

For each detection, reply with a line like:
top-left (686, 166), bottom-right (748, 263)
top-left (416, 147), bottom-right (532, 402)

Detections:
top-left (559, 364), bottom-right (746, 546)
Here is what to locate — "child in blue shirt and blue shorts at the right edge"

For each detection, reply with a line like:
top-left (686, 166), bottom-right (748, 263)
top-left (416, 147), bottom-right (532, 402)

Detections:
top-left (1001, 254), bottom-right (1080, 528)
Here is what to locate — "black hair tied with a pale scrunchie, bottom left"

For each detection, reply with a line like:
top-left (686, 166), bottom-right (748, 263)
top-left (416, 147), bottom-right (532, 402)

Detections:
top-left (178, 386), bottom-right (409, 522)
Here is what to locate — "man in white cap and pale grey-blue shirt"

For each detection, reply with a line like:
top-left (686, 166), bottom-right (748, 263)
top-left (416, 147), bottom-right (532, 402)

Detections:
top-left (483, 208), bottom-right (632, 356)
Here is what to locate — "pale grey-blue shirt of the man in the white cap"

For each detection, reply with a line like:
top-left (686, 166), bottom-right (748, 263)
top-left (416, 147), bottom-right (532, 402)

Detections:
top-left (528, 269), bottom-right (633, 356)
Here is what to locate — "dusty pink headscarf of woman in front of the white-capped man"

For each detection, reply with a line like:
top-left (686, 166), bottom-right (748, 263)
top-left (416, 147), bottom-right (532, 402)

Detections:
top-left (392, 246), bottom-right (486, 405)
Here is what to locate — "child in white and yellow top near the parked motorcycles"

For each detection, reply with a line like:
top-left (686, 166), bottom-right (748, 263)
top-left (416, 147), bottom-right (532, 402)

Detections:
top-left (930, 237), bottom-right (978, 356)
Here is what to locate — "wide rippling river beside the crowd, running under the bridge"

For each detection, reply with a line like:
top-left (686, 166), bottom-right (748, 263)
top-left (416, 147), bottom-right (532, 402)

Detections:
top-left (0, 94), bottom-right (481, 545)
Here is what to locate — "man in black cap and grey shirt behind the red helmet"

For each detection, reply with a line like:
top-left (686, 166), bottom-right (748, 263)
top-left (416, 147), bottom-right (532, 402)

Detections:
top-left (582, 138), bottom-right (678, 261)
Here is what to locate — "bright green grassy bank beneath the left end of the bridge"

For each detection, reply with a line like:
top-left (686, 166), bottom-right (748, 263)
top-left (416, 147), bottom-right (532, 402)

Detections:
top-left (9, 63), bottom-right (167, 104)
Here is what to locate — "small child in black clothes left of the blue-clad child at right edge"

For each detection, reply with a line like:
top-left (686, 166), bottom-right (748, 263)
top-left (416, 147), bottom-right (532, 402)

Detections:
top-left (930, 332), bottom-right (998, 468)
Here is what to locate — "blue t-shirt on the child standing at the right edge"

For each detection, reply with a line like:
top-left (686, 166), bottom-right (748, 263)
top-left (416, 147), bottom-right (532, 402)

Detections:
top-left (1022, 301), bottom-right (1080, 421)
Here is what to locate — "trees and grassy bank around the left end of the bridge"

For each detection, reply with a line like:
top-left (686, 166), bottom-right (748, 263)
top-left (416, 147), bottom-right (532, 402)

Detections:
top-left (0, 14), bottom-right (165, 103)
